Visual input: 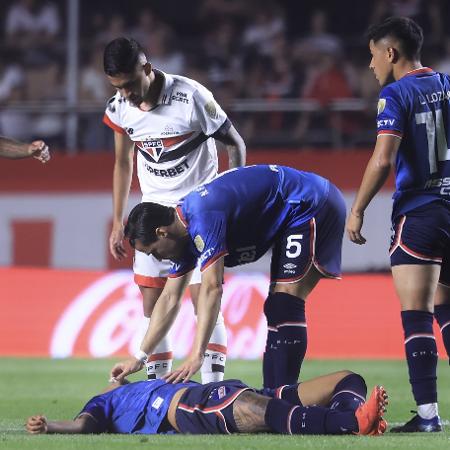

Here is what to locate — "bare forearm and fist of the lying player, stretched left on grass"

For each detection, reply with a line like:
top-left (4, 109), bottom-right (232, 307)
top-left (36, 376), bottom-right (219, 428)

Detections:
top-left (25, 414), bottom-right (98, 434)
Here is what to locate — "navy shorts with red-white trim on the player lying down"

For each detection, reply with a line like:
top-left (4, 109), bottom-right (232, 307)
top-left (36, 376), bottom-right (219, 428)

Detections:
top-left (176, 380), bottom-right (253, 434)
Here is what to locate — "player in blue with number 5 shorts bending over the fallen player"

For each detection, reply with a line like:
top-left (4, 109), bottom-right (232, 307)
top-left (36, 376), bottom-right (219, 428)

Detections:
top-left (111, 166), bottom-right (345, 388)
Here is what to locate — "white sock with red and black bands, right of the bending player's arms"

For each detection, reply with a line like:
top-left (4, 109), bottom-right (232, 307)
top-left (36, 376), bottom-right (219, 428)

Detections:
top-left (200, 311), bottom-right (227, 384)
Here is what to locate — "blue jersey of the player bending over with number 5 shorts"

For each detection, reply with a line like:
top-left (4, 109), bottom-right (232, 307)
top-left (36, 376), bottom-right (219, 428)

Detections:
top-left (169, 165), bottom-right (330, 278)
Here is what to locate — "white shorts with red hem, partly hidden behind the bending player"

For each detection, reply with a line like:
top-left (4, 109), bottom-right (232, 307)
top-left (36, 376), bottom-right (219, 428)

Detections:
top-left (133, 250), bottom-right (202, 288)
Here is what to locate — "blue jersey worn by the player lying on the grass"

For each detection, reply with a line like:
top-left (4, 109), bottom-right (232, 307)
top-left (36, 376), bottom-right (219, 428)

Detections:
top-left (78, 380), bottom-right (198, 434)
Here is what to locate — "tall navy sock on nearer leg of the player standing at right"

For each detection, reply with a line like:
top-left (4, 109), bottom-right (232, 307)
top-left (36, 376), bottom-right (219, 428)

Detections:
top-left (401, 311), bottom-right (438, 405)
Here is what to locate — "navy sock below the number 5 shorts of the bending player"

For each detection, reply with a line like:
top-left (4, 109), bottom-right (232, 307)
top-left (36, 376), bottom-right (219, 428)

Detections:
top-left (263, 292), bottom-right (307, 388)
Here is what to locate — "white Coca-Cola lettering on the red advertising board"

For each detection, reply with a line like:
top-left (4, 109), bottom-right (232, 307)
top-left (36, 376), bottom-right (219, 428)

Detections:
top-left (50, 271), bottom-right (269, 359)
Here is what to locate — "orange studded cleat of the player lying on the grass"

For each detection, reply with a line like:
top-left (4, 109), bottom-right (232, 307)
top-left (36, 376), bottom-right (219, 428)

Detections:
top-left (355, 386), bottom-right (388, 436)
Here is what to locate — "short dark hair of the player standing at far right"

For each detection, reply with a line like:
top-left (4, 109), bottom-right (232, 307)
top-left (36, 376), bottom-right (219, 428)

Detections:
top-left (366, 17), bottom-right (423, 60)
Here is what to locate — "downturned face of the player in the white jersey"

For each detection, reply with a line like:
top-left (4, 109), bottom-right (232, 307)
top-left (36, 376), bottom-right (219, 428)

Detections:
top-left (108, 61), bottom-right (151, 107)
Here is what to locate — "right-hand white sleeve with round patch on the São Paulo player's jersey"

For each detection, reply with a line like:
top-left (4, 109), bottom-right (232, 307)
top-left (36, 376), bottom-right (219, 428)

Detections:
top-left (192, 85), bottom-right (229, 136)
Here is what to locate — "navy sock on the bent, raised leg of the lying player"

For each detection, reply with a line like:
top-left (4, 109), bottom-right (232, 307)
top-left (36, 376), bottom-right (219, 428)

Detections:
top-left (330, 373), bottom-right (367, 411)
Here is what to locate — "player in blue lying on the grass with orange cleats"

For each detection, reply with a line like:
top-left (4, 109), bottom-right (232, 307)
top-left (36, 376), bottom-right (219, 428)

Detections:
top-left (26, 370), bottom-right (387, 435)
